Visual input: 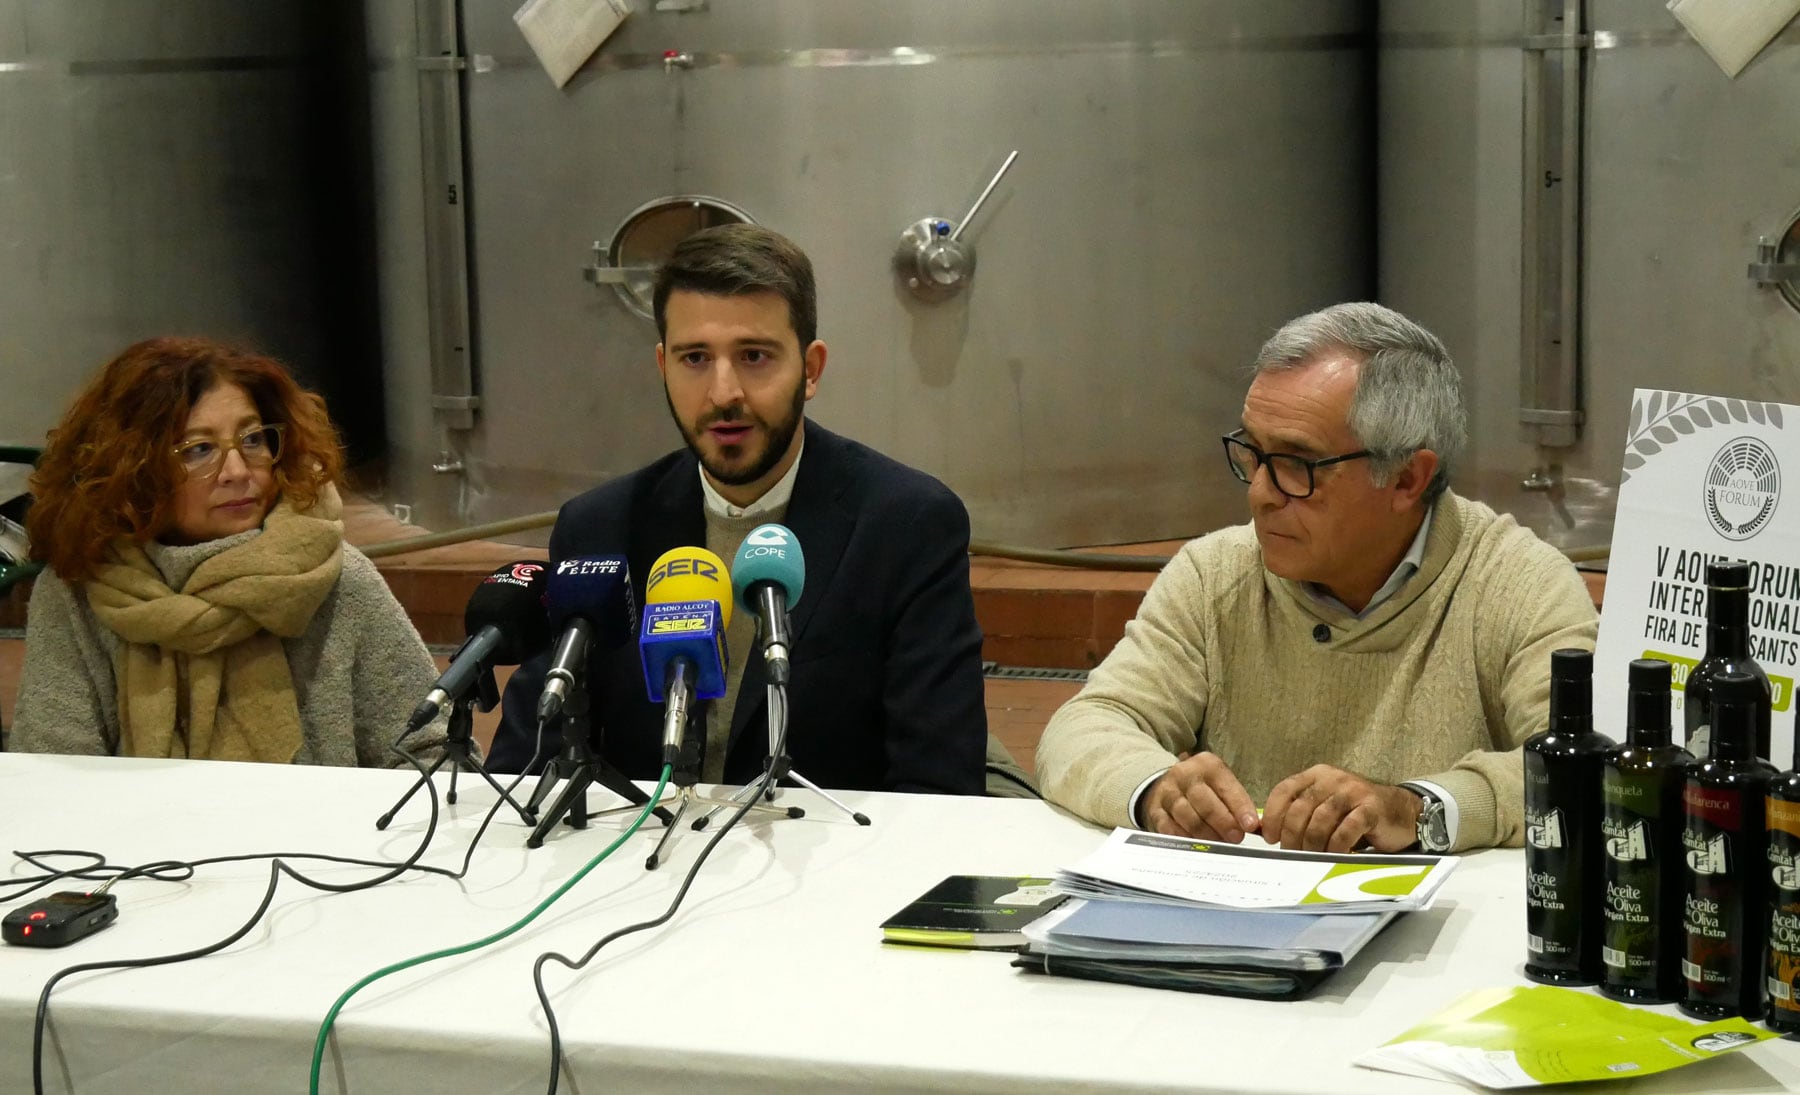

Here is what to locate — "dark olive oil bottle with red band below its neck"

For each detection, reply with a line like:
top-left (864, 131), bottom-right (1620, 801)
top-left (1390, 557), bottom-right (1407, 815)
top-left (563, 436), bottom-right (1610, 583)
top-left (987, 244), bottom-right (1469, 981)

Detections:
top-left (1679, 674), bottom-right (1775, 1019)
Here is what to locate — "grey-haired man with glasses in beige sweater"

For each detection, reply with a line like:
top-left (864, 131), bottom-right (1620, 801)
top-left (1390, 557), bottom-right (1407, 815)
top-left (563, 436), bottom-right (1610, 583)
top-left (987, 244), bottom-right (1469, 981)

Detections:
top-left (1037, 303), bottom-right (1597, 852)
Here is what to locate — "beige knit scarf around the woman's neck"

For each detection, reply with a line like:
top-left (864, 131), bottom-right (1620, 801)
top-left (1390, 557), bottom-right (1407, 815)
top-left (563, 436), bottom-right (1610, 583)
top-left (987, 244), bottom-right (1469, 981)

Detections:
top-left (83, 486), bottom-right (344, 764)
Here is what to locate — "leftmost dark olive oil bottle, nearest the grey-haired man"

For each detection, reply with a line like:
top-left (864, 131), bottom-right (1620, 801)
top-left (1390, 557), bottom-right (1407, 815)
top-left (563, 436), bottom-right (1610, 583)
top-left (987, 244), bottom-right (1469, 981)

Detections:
top-left (1525, 650), bottom-right (1613, 985)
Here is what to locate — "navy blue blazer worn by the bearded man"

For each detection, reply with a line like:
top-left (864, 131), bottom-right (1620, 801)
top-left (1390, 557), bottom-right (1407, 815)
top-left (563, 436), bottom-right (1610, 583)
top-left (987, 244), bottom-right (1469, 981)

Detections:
top-left (490, 420), bottom-right (988, 794)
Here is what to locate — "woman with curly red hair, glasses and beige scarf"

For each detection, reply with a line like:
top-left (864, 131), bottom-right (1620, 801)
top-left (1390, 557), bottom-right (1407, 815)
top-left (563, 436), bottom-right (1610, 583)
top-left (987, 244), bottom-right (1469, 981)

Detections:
top-left (7, 339), bottom-right (441, 765)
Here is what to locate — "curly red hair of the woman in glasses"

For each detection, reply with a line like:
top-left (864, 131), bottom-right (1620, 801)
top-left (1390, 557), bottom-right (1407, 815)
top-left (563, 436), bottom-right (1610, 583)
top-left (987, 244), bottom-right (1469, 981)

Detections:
top-left (25, 339), bottom-right (344, 582)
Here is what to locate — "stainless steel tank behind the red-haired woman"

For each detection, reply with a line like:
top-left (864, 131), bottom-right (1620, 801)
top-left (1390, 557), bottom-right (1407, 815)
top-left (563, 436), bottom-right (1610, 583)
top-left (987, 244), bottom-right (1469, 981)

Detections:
top-left (0, 0), bottom-right (380, 445)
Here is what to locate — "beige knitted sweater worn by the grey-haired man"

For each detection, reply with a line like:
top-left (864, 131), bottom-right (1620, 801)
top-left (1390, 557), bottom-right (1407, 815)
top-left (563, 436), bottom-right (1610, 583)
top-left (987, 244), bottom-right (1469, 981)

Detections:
top-left (1037, 492), bottom-right (1597, 850)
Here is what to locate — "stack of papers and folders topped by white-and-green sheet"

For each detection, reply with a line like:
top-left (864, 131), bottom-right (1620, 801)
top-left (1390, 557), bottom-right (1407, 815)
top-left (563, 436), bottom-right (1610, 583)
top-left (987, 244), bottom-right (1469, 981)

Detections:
top-left (1015, 828), bottom-right (1456, 998)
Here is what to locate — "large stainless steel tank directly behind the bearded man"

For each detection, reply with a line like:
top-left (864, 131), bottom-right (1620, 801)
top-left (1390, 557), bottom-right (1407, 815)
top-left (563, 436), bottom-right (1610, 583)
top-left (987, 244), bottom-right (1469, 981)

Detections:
top-left (369, 0), bottom-right (1373, 546)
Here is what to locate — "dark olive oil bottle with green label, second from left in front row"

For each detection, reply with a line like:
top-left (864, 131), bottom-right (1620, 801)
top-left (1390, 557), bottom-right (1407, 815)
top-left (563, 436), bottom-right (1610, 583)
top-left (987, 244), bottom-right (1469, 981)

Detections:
top-left (1600, 659), bottom-right (1694, 1003)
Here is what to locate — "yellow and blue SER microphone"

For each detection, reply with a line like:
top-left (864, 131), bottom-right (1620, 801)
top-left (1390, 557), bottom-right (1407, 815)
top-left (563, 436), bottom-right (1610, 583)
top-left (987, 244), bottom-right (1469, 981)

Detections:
top-left (637, 548), bottom-right (731, 765)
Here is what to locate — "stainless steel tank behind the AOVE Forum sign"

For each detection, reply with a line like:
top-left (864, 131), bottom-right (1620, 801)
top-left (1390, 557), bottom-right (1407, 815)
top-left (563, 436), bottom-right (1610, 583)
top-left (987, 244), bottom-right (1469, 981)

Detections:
top-left (1379, 0), bottom-right (1800, 548)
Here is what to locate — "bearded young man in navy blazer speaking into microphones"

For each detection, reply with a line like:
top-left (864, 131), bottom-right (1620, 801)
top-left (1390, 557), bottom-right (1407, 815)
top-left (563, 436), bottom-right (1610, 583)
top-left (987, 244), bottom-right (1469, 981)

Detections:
top-left (490, 225), bottom-right (988, 794)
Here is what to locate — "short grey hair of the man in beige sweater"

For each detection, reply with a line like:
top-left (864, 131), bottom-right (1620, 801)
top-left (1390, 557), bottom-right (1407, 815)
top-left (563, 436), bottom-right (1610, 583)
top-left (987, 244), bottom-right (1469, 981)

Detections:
top-left (1255, 301), bottom-right (1469, 504)
